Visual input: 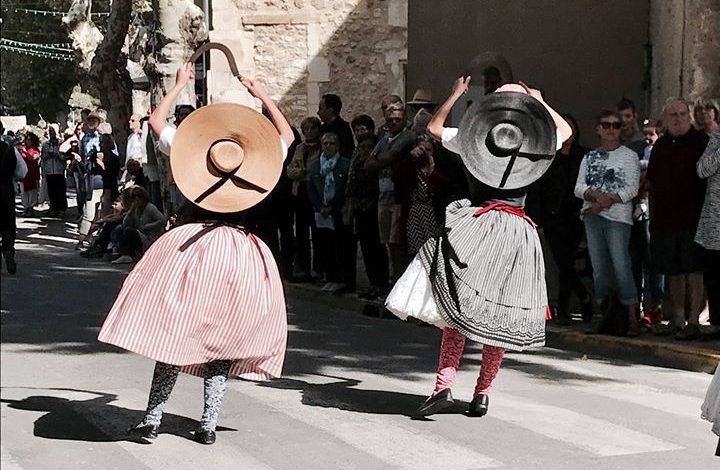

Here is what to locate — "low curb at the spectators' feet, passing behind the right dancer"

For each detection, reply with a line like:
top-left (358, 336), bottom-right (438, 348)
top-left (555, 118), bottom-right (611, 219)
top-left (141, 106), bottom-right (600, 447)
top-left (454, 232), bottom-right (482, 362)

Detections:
top-left (285, 283), bottom-right (720, 374)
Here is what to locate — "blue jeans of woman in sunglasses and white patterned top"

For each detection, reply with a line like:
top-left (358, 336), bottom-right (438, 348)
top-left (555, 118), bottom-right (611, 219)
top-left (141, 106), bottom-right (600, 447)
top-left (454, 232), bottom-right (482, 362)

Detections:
top-left (585, 214), bottom-right (638, 305)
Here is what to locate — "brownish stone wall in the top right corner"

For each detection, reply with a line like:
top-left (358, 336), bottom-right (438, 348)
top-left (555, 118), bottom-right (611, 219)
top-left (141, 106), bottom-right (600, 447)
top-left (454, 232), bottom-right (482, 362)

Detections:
top-left (650, 0), bottom-right (720, 117)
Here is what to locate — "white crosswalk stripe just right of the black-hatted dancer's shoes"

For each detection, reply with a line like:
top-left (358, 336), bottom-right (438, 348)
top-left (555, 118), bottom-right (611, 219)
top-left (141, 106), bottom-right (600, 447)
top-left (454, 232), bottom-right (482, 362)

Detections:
top-left (492, 393), bottom-right (683, 456)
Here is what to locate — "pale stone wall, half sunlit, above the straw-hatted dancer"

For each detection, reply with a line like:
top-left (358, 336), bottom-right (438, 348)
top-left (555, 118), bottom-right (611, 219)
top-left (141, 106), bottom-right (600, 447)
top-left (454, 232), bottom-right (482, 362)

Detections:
top-left (208, 0), bottom-right (408, 125)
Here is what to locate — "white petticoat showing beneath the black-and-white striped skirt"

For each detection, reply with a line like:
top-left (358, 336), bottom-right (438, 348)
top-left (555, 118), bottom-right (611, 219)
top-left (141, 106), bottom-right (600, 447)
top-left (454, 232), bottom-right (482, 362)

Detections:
top-left (385, 256), bottom-right (448, 329)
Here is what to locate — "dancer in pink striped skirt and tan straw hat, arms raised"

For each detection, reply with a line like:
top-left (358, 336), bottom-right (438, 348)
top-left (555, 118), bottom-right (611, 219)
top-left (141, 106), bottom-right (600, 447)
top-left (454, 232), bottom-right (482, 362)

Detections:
top-left (98, 49), bottom-right (293, 444)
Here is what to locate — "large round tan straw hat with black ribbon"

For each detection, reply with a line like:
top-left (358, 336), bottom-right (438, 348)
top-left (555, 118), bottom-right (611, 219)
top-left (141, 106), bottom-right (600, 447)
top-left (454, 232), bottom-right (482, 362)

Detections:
top-left (170, 103), bottom-right (283, 213)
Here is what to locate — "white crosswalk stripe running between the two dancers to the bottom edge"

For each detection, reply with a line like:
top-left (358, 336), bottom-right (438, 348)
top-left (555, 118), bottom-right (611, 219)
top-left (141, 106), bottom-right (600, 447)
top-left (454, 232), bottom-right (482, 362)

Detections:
top-left (231, 376), bottom-right (502, 470)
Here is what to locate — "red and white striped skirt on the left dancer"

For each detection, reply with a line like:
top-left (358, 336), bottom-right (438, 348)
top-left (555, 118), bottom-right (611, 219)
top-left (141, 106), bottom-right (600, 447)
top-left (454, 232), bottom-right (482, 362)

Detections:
top-left (98, 223), bottom-right (287, 380)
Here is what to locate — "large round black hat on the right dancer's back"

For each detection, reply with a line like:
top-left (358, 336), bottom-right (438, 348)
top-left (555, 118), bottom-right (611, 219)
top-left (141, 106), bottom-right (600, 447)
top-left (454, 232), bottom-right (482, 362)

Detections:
top-left (458, 91), bottom-right (557, 189)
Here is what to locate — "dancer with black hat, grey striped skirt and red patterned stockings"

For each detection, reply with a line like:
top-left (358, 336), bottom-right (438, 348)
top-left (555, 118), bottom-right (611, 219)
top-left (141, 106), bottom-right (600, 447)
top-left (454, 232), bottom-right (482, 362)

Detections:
top-left (387, 77), bottom-right (572, 416)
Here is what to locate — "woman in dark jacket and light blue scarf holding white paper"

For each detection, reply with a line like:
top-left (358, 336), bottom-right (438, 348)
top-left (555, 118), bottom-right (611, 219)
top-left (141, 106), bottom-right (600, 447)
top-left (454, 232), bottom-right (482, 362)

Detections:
top-left (308, 132), bottom-right (354, 293)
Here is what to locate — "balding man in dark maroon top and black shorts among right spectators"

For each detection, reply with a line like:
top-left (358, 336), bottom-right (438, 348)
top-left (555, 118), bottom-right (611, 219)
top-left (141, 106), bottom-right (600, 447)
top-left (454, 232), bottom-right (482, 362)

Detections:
top-left (647, 98), bottom-right (708, 340)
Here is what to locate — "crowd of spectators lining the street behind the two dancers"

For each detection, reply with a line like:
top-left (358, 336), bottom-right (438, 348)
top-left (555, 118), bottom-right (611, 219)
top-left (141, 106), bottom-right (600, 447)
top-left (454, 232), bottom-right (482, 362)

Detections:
top-left (1, 85), bottom-right (720, 340)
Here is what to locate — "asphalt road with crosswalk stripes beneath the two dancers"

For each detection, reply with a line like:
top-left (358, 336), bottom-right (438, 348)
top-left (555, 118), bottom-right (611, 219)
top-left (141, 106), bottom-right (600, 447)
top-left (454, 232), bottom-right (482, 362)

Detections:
top-left (0, 214), bottom-right (720, 470)
